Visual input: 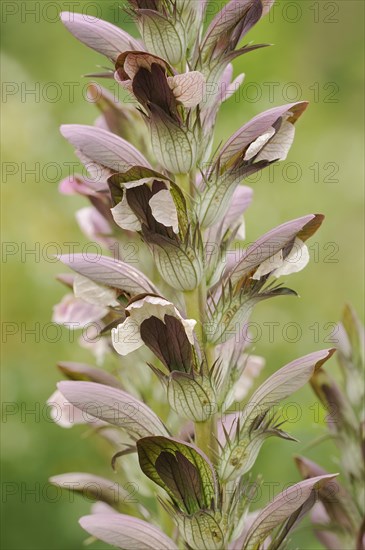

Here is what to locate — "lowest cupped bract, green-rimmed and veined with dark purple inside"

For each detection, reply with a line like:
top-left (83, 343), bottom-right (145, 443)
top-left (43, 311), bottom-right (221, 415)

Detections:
top-left (137, 437), bottom-right (217, 514)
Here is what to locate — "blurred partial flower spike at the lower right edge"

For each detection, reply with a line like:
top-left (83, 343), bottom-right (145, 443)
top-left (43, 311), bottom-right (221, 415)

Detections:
top-left (296, 306), bottom-right (365, 550)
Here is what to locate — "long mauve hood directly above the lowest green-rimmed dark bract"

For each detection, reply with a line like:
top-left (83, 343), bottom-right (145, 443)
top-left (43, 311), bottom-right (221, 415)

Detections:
top-left (58, 382), bottom-right (168, 438)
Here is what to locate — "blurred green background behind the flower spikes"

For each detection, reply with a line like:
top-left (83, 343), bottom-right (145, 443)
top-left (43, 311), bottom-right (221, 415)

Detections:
top-left (1, 0), bottom-right (364, 550)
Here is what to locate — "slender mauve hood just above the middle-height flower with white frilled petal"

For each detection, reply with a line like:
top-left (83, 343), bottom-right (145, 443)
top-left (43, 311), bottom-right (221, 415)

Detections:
top-left (59, 254), bottom-right (158, 296)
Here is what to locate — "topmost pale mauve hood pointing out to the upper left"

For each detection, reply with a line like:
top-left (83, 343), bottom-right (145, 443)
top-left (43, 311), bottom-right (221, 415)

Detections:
top-left (60, 11), bottom-right (142, 61)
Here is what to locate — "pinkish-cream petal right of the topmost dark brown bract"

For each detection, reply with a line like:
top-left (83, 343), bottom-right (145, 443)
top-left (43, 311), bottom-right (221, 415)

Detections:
top-left (167, 71), bottom-right (206, 108)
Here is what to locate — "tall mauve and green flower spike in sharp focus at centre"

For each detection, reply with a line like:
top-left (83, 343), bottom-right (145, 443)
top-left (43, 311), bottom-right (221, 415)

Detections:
top-left (49, 0), bottom-right (333, 550)
